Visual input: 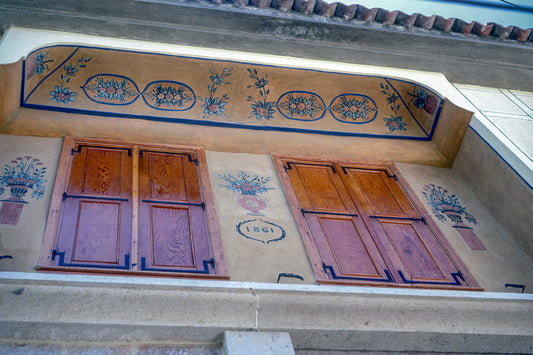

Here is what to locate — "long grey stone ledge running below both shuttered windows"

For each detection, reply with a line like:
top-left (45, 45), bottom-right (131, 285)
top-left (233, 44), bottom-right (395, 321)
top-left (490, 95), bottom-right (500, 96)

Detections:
top-left (0, 272), bottom-right (533, 353)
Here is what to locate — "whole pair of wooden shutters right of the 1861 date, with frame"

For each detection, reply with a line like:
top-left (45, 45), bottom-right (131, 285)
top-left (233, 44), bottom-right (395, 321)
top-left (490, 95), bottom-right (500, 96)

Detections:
top-left (273, 154), bottom-right (480, 290)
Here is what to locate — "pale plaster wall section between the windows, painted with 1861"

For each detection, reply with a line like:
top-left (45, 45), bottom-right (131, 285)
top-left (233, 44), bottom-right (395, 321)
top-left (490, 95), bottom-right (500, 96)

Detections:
top-left (207, 151), bottom-right (315, 284)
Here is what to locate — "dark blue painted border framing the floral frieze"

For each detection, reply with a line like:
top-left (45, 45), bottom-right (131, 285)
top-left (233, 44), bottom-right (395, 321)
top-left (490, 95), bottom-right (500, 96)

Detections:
top-left (20, 44), bottom-right (443, 141)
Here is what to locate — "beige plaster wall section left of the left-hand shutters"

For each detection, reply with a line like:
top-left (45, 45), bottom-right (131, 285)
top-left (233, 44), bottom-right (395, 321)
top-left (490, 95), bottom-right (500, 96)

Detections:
top-left (0, 135), bottom-right (63, 271)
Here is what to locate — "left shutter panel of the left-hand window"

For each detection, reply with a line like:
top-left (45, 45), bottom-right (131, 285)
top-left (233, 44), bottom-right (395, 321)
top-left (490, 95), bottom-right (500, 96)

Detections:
top-left (53, 145), bottom-right (132, 269)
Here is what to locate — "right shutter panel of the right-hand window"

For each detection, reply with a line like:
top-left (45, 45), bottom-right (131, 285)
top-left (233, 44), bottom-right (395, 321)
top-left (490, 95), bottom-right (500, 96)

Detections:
top-left (342, 167), bottom-right (462, 286)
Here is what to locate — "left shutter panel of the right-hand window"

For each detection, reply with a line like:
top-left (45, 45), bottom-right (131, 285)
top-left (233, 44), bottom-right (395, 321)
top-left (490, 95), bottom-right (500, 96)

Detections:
top-left (285, 162), bottom-right (393, 284)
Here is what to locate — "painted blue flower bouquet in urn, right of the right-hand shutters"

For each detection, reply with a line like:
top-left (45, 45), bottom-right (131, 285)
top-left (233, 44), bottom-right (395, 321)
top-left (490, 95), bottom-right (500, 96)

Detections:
top-left (422, 184), bottom-right (477, 224)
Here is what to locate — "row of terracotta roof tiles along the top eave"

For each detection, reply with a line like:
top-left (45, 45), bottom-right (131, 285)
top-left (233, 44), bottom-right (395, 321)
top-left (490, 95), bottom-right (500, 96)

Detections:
top-left (206, 0), bottom-right (533, 43)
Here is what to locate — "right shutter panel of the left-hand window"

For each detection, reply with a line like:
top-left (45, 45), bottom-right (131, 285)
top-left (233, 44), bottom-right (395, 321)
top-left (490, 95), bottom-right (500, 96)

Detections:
top-left (139, 149), bottom-right (214, 274)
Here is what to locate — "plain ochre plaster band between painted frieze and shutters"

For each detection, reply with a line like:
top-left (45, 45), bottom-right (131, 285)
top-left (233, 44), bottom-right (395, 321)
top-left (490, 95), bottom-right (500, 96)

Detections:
top-left (1, 108), bottom-right (444, 166)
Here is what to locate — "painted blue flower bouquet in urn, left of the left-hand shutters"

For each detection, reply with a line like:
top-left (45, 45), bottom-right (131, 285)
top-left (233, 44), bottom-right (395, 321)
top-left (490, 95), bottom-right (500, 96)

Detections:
top-left (0, 156), bottom-right (47, 203)
